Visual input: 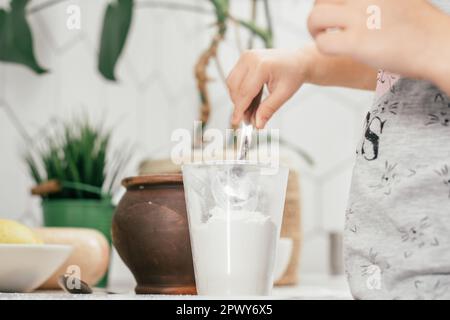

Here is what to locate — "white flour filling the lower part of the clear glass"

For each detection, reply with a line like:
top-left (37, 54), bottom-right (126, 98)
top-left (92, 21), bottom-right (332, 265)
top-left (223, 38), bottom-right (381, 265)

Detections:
top-left (192, 207), bottom-right (278, 295)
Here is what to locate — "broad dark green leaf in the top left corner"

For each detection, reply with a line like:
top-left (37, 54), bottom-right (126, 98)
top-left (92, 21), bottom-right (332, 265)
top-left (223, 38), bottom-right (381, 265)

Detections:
top-left (0, 0), bottom-right (46, 74)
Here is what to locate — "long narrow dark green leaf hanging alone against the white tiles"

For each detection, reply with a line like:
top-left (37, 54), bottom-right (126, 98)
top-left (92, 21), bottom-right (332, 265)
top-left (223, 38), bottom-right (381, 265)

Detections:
top-left (98, 0), bottom-right (133, 81)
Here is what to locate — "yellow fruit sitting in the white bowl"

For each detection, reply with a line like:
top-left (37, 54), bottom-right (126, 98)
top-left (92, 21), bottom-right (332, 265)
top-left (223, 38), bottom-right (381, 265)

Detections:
top-left (0, 219), bottom-right (43, 244)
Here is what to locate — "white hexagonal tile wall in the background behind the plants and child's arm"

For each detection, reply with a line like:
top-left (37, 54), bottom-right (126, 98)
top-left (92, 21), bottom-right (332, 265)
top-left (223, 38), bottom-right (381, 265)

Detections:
top-left (0, 0), bottom-right (371, 280)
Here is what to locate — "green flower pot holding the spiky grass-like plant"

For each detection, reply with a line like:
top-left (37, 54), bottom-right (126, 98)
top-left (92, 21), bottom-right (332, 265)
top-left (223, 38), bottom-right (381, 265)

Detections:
top-left (42, 199), bottom-right (114, 288)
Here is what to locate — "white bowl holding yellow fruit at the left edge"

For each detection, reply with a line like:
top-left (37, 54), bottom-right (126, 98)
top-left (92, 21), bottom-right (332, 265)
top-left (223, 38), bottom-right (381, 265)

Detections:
top-left (0, 244), bottom-right (72, 292)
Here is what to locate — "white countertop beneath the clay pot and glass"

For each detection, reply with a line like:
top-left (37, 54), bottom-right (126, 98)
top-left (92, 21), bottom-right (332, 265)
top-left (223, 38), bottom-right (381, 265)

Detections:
top-left (0, 276), bottom-right (352, 300)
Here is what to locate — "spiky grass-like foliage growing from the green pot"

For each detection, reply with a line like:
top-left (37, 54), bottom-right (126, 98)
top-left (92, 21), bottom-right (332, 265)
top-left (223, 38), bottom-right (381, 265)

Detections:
top-left (25, 119), bottom-right (129, 199)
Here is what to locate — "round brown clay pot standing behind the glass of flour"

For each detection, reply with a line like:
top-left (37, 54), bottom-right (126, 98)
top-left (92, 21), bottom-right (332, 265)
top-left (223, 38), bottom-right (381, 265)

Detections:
top-left (112, 174), bottom-right (196, 294)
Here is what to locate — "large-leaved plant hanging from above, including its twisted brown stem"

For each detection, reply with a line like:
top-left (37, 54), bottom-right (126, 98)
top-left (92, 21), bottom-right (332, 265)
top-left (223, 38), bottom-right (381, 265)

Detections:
top-left (0, 0), bottom-right (273, 126)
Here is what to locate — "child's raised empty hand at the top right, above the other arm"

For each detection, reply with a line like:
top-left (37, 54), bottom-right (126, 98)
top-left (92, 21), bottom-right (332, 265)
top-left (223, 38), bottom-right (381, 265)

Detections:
top-left (308, 0), bottom-right (450, 77)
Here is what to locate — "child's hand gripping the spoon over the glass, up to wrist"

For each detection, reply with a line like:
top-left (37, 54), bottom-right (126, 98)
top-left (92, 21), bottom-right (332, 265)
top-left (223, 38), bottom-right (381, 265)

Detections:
top-left (227, 49), bottom-right (310, 129)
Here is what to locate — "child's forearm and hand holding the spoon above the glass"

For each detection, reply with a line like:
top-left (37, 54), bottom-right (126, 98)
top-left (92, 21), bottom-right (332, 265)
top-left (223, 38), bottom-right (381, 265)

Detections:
top-left (227, 45), bottom-right (377, 128)
